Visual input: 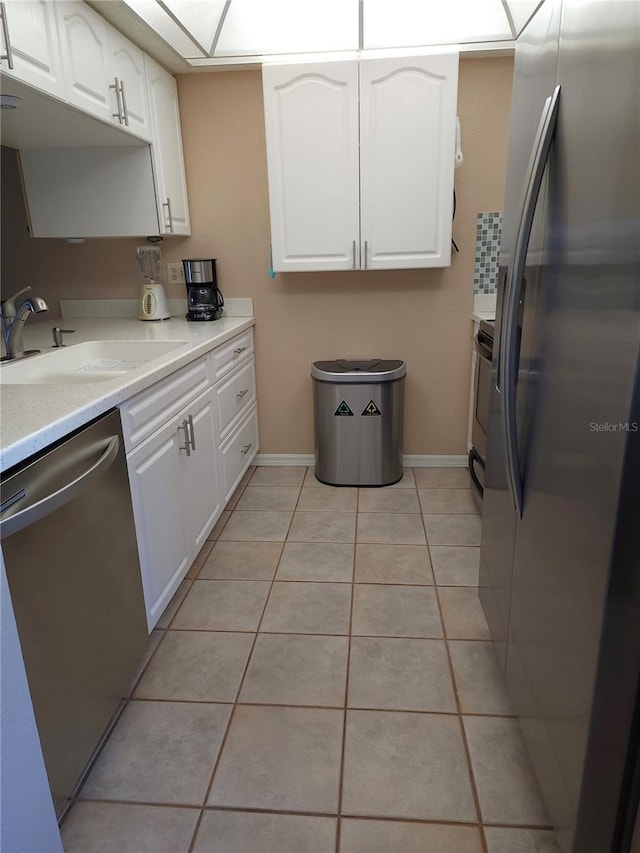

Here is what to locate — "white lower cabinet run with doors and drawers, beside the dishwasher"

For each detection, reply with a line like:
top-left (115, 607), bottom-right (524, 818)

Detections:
top-left (121, 330), bottom-right (258, 631)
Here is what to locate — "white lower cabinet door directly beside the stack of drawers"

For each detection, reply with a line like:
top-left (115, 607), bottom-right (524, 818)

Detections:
top-left (181, 390), bottom-right (222, 557)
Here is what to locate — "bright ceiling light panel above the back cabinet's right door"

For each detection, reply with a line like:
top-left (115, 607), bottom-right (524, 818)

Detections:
top-left (363, 0), bottom-right (512, 48)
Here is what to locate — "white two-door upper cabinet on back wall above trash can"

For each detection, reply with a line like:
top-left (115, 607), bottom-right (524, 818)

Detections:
top-left (263, 52), bottom-right (458, 272)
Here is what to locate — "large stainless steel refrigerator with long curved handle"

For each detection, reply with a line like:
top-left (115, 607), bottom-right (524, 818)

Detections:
top-left (480, 0), bottom-right (640, 853)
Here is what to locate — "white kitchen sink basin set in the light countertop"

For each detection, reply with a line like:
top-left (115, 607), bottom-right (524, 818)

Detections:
top-left (0, 341), bottom-right (188, 385)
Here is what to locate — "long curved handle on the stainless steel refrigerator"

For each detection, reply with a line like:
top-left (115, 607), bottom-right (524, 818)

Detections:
top-left (498, 86), bottom-right (560, 518)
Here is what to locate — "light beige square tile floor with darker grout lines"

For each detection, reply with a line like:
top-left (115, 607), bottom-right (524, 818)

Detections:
top-left (62, 467), bottom-right (557, 853)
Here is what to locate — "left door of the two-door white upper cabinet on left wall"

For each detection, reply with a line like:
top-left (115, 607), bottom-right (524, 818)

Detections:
top-left (55, 0), bottom-right (115, 123)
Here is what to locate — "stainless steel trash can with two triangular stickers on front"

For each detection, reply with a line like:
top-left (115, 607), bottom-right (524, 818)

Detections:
top-left (311, 358), bottom-right (407, 486)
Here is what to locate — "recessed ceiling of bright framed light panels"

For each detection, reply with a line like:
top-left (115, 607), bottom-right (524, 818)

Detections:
top-left (91, 0), bottom-right (544, 70)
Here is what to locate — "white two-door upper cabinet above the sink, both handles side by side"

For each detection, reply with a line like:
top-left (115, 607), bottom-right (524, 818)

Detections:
top-left (55, 0), bottom-right (151, 141)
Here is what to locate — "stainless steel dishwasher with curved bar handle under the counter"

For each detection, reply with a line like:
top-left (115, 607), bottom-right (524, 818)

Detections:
top-left (0, 411), bottom-right (147, 818)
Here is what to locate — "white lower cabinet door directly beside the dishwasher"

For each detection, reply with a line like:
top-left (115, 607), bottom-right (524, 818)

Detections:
top-left (127, 419), bottom-right (192, 631)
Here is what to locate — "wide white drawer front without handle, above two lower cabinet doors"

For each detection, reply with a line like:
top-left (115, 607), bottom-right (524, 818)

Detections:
top-left (120, 356), bottom-right (211, 452)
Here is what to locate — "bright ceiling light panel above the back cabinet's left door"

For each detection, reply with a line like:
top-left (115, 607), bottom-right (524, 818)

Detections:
top-left (215, 0), bottom-right (358, 56)
